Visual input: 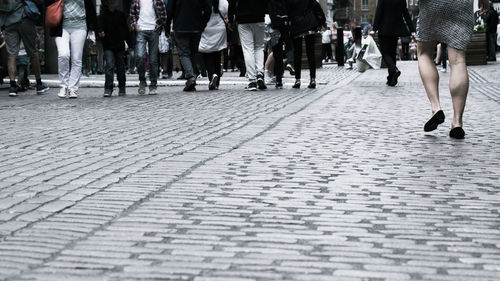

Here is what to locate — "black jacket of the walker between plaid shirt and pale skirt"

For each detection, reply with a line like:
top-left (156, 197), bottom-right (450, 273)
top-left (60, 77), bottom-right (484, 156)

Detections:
top-left (166, 0), bottom-right (212, 33)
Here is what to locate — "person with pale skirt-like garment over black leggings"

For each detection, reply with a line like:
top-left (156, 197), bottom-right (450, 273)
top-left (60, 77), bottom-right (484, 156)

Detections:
top-left (199, 0), bottom-right (229, 90)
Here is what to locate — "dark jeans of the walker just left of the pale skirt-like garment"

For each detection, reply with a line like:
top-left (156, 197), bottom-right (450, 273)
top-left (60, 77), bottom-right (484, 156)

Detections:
top-left (175, 32), bottom-right (201, 81)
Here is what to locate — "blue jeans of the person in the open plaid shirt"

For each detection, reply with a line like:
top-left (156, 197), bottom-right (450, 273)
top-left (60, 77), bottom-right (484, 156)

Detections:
top-left (135, 30), bottom-right (159, 88)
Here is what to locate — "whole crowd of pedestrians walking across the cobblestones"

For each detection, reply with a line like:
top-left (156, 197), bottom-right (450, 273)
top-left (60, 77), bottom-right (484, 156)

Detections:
top-left (0, 0), bottom-right (498, 138)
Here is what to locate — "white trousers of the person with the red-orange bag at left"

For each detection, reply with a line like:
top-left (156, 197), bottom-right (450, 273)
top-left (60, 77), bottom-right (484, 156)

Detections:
top-left (56, 28), bottom-right (87, 92)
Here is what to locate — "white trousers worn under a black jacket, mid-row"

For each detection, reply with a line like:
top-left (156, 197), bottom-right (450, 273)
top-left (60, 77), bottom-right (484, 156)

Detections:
top-left (238, 22), bottom-right (265, 82)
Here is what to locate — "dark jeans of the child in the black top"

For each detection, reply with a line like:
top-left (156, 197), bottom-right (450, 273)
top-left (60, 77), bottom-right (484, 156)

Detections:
top-left (104, 50), bottom-right (126, 90)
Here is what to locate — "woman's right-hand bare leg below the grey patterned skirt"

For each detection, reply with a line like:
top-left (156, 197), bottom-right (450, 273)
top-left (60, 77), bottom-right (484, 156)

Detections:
top-left (448, 47), bottom-right (469, 128)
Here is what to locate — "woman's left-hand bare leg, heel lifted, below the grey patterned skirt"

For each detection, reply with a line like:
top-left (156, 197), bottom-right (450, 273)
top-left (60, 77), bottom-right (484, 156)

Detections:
top-left (418, 42), bottom-right (441, 115)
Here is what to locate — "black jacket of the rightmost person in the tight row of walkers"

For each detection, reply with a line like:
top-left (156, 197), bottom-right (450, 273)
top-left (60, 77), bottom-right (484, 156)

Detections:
top-left (285, 0), bottom-right (326, 37)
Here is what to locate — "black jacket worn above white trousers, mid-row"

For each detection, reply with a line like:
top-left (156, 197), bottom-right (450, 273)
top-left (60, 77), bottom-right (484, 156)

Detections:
top-left (228, 0), bottom-right (269, 24)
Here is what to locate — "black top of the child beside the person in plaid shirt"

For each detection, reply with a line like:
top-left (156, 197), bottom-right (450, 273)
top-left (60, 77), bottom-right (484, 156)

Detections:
top-left (97, 6), bottom-right (130, 51)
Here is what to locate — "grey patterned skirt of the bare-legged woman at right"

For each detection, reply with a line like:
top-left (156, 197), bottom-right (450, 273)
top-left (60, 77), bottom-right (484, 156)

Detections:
top-left (417, 0), bottom-right (474, 50)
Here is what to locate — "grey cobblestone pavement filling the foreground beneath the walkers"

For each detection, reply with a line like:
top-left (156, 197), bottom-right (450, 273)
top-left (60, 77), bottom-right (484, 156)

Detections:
top-left (0, 63), bottom-right (500, 281)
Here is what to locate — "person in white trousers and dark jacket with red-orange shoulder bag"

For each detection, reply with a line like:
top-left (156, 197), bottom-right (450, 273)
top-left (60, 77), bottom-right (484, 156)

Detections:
top-left (46, 0), bottom-right (97, 99)
